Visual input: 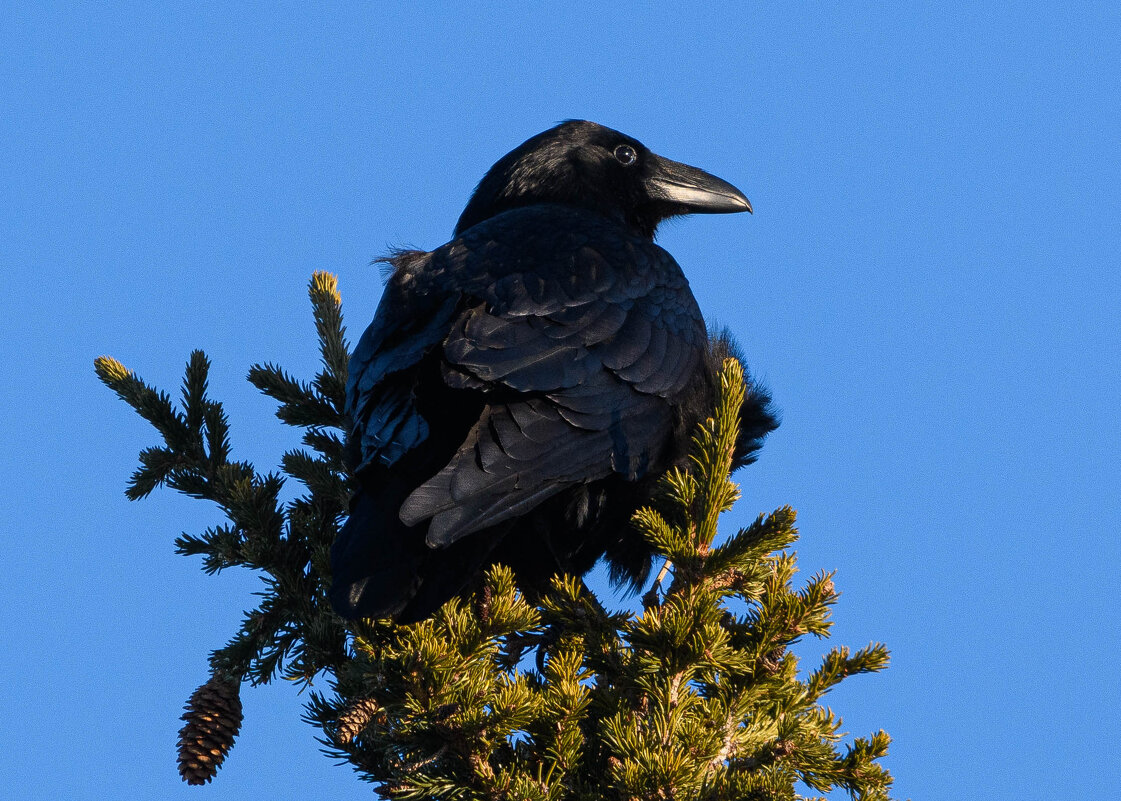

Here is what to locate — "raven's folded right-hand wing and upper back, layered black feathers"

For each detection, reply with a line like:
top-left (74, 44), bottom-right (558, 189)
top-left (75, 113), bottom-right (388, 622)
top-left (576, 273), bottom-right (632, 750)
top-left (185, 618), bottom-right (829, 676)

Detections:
top-left (397, 203), bottom-right (707, 547)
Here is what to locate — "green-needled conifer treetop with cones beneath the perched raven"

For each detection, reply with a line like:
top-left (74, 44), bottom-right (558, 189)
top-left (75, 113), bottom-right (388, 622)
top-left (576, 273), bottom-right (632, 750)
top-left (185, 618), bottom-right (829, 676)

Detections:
top-left (95, 272), bottom-right (891, 801)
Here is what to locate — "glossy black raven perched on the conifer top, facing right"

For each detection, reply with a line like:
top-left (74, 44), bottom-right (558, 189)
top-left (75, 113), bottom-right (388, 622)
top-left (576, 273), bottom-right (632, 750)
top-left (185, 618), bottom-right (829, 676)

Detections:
top-left (331, 121), bottom-right (777, 622)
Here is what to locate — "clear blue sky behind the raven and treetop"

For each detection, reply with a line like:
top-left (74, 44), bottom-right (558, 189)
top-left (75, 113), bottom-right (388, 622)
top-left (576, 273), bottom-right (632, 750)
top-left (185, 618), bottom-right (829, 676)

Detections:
top-left (0, 2), bottom-right (1121, 800)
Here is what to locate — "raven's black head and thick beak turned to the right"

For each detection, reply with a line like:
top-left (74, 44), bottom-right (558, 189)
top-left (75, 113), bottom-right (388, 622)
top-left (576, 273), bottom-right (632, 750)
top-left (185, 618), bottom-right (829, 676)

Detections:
top-left (455, 120), bottom-right (751, 236)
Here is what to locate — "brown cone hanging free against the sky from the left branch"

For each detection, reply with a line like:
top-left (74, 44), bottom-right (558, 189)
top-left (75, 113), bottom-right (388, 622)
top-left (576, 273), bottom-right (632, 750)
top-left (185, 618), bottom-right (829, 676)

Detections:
top-left (179, 676), bottom-right (241, 784)
